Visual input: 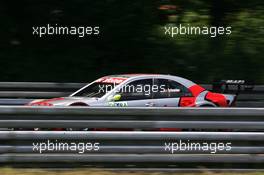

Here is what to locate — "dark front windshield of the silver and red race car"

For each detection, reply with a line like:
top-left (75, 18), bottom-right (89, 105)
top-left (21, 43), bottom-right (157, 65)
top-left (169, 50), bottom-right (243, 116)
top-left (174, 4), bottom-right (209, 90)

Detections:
top-left (73, 82), bottom-right (115, 98)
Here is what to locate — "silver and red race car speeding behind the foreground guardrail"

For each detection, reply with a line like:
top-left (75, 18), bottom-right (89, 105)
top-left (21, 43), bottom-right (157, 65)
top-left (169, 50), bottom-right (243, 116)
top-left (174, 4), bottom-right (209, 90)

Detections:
top-left (28, 74), bottom-right (236, 107)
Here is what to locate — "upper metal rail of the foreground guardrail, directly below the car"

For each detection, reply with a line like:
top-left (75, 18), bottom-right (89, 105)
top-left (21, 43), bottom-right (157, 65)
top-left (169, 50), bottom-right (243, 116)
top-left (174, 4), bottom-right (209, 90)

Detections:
top-left (0, 106), bottom-right (264, 129)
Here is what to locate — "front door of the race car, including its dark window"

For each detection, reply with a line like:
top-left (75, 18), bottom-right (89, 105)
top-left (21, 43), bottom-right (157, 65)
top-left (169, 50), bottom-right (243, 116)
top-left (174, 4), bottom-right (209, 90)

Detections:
top-left (108, 78), bottom-right (154, 107)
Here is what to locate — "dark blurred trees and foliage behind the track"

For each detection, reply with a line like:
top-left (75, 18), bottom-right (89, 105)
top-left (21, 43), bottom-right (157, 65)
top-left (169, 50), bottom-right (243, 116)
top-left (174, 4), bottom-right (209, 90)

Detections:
top-left (0, 0), bottom-right (264, 84)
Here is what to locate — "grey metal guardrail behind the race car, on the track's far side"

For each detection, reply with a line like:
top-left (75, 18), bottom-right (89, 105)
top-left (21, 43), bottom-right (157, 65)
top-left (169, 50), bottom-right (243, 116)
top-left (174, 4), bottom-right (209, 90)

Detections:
top-left (0, 82), bottom-right (264, 107)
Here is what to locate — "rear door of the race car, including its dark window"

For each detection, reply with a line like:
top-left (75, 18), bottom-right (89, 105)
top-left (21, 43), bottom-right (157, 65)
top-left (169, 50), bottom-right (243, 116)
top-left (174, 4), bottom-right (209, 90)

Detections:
top-left (153, 78), bottom-right (192, 107)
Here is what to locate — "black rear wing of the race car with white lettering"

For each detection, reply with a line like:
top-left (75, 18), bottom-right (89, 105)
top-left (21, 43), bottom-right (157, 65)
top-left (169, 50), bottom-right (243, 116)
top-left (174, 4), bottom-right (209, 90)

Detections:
top-left (212, 80), bottom-right (254, 94)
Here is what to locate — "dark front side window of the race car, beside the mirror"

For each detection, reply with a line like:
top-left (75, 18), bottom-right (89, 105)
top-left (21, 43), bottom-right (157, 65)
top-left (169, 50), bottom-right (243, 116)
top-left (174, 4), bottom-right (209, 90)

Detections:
top-left (117, 79), bottom-right (153, 101)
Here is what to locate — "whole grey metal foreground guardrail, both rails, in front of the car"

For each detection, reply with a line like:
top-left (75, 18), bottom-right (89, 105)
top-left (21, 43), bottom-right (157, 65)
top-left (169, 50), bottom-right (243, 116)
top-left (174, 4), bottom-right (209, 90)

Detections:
top-left (0, 106), bottom-right (264, 168)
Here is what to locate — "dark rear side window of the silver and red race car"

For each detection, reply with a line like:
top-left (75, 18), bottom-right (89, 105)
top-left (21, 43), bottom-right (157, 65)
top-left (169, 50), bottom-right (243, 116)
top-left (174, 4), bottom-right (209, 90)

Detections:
top-left (153, 79), bottom-right (192, 98)
